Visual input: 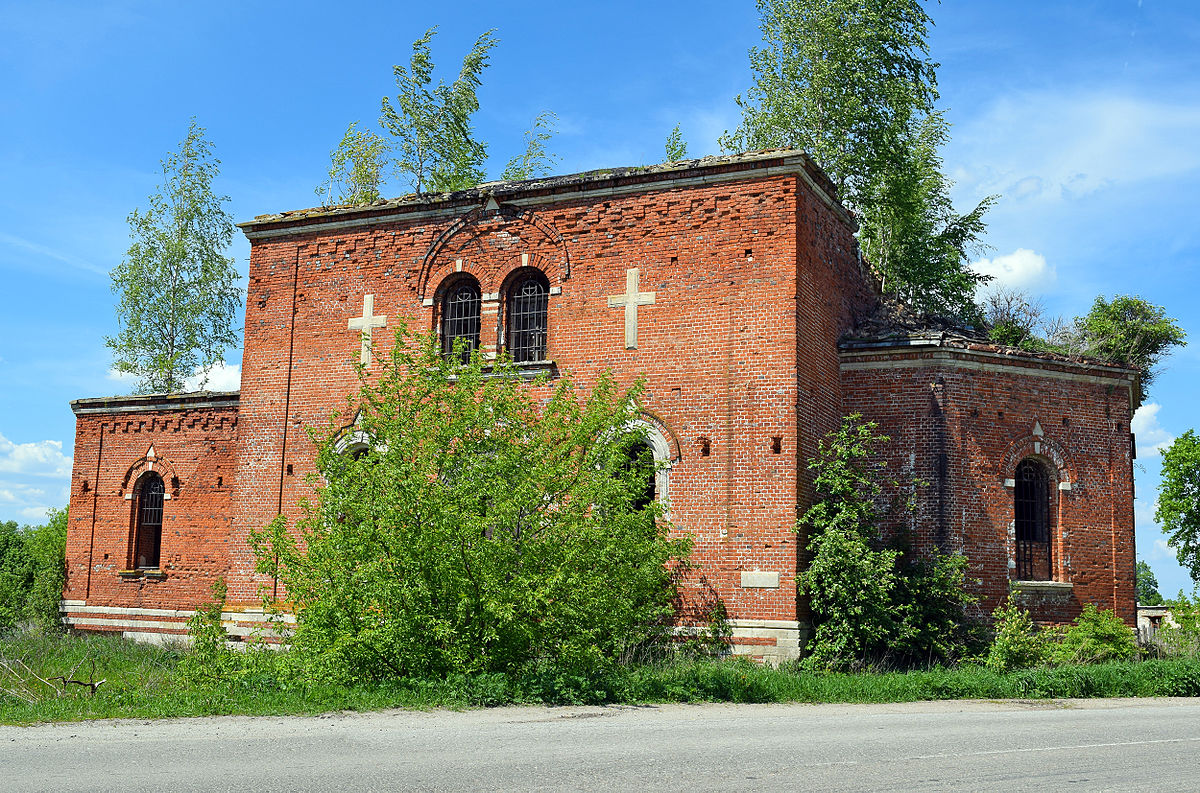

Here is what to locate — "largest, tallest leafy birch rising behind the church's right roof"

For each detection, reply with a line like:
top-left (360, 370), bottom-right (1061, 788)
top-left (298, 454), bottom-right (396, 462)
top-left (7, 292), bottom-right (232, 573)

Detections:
top-left (721, 0), bottom-right (995, 320)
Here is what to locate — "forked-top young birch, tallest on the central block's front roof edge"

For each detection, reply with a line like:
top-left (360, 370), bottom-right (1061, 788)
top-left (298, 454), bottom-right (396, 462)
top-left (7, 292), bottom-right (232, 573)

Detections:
top-left (379, 28), bottom-right (498, 193)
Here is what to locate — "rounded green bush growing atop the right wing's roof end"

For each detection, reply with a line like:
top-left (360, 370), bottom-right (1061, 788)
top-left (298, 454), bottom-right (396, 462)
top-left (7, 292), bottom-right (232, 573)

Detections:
top-left (1075, 295), bottom-right (1187, 404)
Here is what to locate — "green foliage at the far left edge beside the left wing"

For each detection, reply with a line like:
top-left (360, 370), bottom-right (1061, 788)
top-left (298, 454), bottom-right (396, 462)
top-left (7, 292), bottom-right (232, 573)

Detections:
top-left (0, 510), bottom-right (67, 632)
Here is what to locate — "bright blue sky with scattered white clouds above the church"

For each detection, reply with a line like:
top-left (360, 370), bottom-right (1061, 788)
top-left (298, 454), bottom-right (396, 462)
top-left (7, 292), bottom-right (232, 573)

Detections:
top-left (0, 0), bottom-right (1200, 594)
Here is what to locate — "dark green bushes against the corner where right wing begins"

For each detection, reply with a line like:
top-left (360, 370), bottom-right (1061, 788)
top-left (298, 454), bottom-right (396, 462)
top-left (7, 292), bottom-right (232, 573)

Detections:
top-left (799, 415), bottom-right (974, 669)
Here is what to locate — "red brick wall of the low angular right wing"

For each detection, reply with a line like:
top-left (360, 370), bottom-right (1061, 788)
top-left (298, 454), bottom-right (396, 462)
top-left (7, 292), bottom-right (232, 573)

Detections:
top-left (842, 347), bottom-right (1135, 625)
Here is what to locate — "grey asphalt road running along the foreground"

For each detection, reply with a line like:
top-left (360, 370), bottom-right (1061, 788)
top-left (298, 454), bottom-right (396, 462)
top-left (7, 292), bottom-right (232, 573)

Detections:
top-left (0, 699), bottom-right (1200, 793)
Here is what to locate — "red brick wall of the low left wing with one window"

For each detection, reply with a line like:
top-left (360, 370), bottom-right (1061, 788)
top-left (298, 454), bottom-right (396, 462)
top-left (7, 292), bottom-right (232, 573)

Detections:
top-left (64, 396), bottom-right (238, 609)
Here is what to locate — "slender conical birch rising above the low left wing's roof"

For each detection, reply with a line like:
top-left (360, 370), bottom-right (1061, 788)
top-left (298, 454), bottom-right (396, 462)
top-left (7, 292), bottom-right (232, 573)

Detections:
top-left (104, 119), bottom-right (241, 394)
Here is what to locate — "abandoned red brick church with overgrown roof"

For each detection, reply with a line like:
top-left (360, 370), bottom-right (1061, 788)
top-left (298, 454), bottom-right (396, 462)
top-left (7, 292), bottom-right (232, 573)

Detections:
top-left (62, 151), bottom-right (1136, 660)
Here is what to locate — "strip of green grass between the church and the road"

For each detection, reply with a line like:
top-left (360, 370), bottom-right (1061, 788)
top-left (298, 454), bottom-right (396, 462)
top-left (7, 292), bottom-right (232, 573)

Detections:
top-left (0, 633), bottom-right (1200, 723)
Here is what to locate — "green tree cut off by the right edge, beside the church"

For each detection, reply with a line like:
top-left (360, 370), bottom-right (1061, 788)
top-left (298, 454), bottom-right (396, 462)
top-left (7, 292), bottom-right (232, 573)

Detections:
top-left (1154, 429), bottom-right (1200, 583)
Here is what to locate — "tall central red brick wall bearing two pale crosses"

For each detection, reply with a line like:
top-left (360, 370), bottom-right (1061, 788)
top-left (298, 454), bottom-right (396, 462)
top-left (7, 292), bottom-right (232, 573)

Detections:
top-left (230, 160), bottom-right (870, 620)
